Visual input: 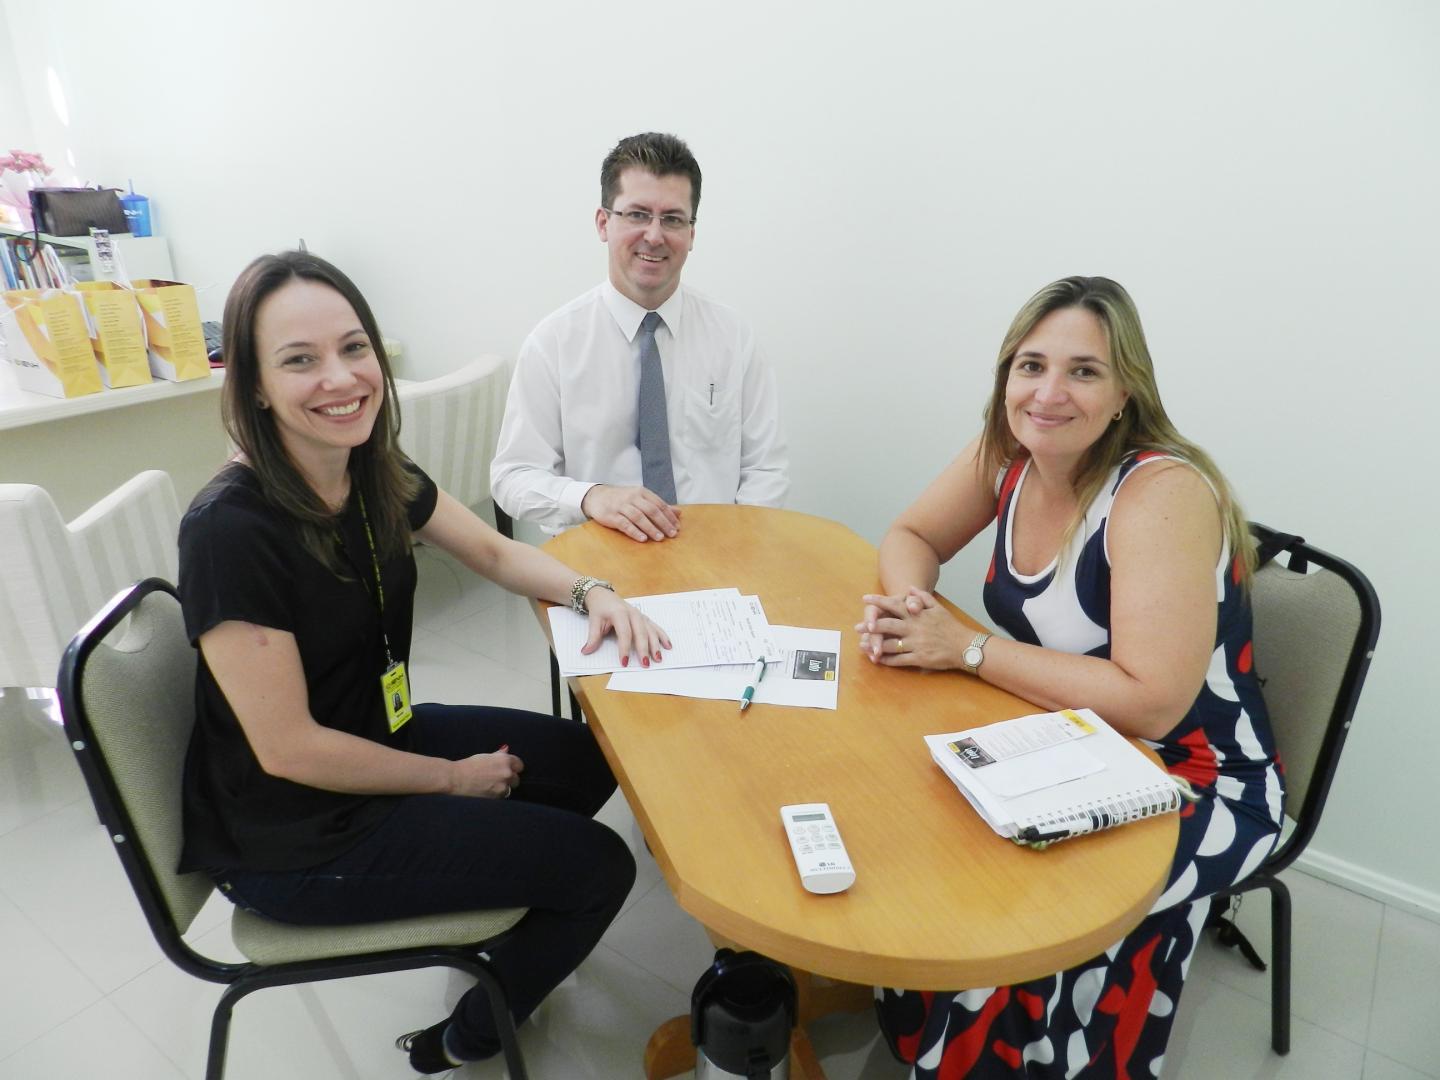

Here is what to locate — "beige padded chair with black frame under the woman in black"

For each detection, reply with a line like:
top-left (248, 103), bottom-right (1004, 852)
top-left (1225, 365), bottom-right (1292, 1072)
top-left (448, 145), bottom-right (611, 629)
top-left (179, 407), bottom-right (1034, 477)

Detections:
top-left (59, 579), bottom-right (526, 1080)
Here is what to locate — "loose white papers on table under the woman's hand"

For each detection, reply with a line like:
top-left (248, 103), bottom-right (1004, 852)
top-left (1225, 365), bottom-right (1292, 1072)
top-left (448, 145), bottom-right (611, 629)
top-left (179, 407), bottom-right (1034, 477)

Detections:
top-left (550, 589), bottom-right (840, 708)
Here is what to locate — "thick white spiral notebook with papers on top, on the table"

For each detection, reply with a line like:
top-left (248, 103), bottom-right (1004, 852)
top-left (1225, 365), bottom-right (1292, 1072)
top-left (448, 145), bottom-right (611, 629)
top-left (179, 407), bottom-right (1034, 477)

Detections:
top-left (924, 708), bottom-right (1187, 847)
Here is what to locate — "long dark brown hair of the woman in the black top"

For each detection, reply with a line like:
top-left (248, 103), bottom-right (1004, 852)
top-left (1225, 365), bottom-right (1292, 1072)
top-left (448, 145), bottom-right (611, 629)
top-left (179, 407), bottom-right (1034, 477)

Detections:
top-left (220, 251), bottom-right (419, 577)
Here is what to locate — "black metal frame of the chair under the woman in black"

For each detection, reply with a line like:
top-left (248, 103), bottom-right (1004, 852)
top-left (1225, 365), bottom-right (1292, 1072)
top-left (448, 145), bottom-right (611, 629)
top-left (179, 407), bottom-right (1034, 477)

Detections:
top-left (58, 577), bottom-right (527, 1080)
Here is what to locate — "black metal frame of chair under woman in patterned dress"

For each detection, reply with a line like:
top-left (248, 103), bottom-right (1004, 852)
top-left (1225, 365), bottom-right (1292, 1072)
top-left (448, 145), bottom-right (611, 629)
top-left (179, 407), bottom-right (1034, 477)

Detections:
top-left (1208, 521), bottom-right (1380, 1054)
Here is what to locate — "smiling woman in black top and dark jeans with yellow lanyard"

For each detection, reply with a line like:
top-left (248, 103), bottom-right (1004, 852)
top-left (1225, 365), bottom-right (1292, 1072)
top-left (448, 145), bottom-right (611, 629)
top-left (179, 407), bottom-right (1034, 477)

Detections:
top-left (180, 252), bottom-right (670, 1073)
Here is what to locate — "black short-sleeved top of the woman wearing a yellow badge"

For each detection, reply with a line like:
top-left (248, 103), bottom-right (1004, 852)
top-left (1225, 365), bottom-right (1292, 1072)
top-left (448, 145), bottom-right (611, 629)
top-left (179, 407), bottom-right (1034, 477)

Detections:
top-left (180, 464), bottom-right (436, 871)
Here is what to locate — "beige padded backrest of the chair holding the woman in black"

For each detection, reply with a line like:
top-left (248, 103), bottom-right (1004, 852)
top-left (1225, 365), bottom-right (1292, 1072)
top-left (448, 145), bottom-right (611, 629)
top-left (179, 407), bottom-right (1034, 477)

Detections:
top-left (58, 577), bottom-right (215, 978)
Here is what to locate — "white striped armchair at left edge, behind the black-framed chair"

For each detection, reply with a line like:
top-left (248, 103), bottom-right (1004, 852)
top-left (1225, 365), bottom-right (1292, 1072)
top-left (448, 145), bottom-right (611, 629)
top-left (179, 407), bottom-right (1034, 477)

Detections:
top-left (0, 469), bottom-right (180, 687)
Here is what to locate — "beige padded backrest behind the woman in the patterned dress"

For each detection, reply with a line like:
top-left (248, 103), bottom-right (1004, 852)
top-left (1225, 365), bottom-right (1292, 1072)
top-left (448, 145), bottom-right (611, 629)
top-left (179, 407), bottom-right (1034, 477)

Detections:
top-left (1250, 523), bottom-right (1380, 870)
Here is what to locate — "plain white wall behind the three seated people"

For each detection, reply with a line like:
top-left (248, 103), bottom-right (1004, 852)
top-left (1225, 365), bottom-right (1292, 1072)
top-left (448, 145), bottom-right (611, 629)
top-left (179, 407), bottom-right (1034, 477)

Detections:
top-left (4, 0), bottom-right (1440, 916)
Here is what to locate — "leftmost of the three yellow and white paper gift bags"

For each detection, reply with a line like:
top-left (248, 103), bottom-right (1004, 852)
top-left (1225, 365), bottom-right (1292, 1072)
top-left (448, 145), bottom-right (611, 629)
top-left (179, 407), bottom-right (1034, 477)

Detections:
top-left (0, 289), bottom-right (101, 397)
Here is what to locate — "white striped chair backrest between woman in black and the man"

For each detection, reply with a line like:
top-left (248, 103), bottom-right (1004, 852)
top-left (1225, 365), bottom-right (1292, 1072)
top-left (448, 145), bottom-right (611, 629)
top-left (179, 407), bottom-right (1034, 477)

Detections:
top-left (396, 356), bottom-right (508, 507)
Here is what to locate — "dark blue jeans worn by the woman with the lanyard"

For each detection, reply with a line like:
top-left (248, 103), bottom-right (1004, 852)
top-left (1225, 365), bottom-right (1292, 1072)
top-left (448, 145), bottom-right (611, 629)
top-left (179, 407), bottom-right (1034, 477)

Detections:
top-left (212, 704), bottom-right (635, 1058)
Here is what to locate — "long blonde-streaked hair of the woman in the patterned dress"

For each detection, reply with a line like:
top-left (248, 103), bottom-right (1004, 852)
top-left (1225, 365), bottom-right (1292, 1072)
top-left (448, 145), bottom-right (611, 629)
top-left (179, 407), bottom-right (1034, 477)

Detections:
top-left (978, 276), bottom-right (1254, 580)
